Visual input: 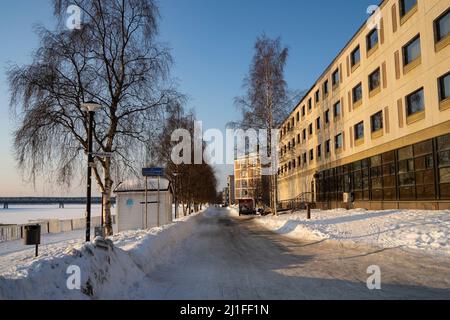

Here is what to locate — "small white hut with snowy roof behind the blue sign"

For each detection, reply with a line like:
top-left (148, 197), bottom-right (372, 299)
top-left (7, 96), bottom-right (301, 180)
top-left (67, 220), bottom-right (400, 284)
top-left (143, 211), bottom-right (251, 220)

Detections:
top-left (114, 178), bottom-right (173, 232)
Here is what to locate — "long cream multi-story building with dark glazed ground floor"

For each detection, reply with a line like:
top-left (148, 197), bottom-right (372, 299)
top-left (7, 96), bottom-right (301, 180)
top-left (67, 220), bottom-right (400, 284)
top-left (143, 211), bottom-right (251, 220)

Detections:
top-left (279, 0), bottom-right (450, 209)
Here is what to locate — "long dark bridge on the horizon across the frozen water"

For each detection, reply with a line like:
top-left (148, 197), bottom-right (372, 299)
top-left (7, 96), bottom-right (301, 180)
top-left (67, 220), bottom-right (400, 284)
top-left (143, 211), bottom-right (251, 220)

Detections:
top-left (0, 197), bottom-right (116, 209)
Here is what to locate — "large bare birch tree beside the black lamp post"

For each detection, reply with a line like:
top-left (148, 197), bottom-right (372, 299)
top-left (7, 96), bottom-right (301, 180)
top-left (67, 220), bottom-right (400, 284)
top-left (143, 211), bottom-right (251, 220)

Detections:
top-left (8, 0), bottom-right (178, 235)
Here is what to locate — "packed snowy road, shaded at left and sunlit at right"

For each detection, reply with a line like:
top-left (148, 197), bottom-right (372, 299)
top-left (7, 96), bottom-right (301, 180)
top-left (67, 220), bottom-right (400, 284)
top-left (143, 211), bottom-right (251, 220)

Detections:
top-left (145, 208), bottom-right (450, 300)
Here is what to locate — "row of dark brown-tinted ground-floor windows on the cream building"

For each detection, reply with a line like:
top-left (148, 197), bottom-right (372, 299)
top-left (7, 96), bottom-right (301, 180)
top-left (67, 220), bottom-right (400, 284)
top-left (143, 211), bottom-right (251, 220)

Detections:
top-left (317, 134), bottom-right (450, 202)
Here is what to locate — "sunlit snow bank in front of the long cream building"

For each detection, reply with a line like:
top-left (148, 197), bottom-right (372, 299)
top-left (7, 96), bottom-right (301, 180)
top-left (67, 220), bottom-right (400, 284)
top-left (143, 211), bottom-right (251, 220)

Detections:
top-left (255, 209), bottom-right (450, 255)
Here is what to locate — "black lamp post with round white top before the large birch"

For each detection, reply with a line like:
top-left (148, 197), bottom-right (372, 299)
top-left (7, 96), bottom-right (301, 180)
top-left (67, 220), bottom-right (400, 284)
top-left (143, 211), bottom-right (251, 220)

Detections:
top-left (81, 101), bottom-right (103, 242)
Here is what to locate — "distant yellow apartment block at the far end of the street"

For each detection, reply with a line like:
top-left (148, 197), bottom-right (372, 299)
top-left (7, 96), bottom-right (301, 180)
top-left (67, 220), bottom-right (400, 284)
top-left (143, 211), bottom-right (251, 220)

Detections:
top-left (234, 154), bottom-right (262, 202)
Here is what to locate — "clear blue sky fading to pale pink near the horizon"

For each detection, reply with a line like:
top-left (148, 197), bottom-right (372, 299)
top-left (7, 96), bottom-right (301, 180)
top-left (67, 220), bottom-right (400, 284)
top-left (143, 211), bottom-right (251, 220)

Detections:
top-left (0, 0), bottom-right (379, 196)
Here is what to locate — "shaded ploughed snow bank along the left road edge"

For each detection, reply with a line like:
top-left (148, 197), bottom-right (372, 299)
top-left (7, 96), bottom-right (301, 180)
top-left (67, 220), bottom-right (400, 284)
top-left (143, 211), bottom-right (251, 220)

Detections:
top-left (0, 215), bottom-right (201, 300)
